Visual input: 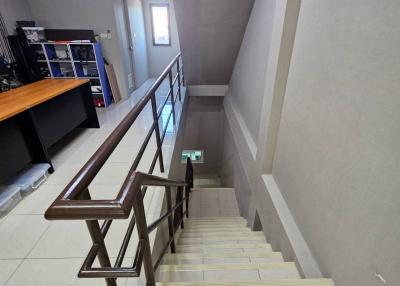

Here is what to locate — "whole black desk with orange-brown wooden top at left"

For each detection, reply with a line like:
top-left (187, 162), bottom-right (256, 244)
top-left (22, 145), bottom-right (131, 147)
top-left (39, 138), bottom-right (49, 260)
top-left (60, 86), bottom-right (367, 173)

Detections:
top-left (0, 79), bottom-right (100, 183)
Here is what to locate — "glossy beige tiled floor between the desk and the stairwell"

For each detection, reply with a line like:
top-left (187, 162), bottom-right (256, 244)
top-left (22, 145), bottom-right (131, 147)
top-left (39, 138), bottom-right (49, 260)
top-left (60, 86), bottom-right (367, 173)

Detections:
top-left (0, 80), bottom-right (186, 286)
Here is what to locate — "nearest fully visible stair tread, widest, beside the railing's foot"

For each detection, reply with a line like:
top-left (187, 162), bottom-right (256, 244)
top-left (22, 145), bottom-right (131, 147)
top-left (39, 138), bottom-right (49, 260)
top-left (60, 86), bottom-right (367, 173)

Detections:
top-left (157, 262), bottom-right (300, 282)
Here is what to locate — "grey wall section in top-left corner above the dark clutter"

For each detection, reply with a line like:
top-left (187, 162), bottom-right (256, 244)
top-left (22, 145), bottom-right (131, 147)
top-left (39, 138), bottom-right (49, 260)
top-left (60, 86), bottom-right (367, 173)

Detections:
top-left (0, 0), bottom-right (32, 35)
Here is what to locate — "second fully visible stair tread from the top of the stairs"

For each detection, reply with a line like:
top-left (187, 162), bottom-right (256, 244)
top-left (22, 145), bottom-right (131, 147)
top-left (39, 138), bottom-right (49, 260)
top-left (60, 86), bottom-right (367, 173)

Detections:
top-left (163, 252), bottom-right (284, 264)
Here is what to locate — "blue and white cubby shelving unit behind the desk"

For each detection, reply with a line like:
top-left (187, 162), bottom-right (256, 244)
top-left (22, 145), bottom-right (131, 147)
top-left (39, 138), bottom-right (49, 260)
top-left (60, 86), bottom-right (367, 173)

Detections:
top-left (30, 42), bottom-right (112, 107)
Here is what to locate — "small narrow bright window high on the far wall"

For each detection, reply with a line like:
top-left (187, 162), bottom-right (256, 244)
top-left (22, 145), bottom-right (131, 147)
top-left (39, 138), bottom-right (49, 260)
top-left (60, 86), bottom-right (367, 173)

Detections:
top-left (150, 4), bottom-right (171, 46)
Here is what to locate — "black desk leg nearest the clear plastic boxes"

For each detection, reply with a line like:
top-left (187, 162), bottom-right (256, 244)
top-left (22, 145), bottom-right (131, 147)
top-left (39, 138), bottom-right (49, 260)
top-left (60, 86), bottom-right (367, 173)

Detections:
top-left (17, 109), bottom-right (54, 174)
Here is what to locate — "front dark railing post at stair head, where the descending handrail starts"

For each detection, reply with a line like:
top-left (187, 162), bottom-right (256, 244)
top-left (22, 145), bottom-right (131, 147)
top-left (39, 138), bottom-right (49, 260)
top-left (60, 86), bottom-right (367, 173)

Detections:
top-left (133, 192), bottom-right (156, 286)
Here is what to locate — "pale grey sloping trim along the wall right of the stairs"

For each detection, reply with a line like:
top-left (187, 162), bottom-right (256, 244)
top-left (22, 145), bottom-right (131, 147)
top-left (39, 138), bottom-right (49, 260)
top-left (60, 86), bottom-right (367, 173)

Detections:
top-left (220, 96), bottom-right (324, 278)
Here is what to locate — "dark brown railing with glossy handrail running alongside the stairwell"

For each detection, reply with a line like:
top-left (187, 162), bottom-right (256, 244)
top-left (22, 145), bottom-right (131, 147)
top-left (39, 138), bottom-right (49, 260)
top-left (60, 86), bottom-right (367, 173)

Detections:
top-left (45, 53), bottom-right (193, 286)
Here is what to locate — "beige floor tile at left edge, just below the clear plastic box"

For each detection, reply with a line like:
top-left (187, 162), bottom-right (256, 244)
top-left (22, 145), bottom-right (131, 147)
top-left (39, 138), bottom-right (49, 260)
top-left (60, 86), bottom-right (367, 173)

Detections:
top-left (0, 215), bottom-right (50, 259)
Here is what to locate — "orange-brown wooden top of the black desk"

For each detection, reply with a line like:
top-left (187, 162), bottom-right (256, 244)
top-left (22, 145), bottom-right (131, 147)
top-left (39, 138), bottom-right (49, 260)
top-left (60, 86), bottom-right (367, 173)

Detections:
top-left (0, 79), bottom-right (89, 121)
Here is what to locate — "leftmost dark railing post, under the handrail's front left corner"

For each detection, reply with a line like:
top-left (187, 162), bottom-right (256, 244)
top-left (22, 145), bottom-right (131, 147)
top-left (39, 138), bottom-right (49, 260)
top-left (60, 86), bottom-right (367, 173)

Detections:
top-left (79, 189), bottom-right (117, 286)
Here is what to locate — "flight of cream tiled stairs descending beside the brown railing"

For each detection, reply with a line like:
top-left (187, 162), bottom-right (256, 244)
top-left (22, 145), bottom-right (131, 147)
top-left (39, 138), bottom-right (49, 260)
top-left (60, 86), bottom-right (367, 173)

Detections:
top-left (156, 185), bottom-right (334, 286)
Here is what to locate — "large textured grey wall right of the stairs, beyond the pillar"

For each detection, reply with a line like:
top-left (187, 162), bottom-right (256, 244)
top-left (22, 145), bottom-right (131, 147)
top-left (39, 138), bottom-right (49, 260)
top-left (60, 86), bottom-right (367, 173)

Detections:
top-left (273, 0), bottom-right (400, 286)
